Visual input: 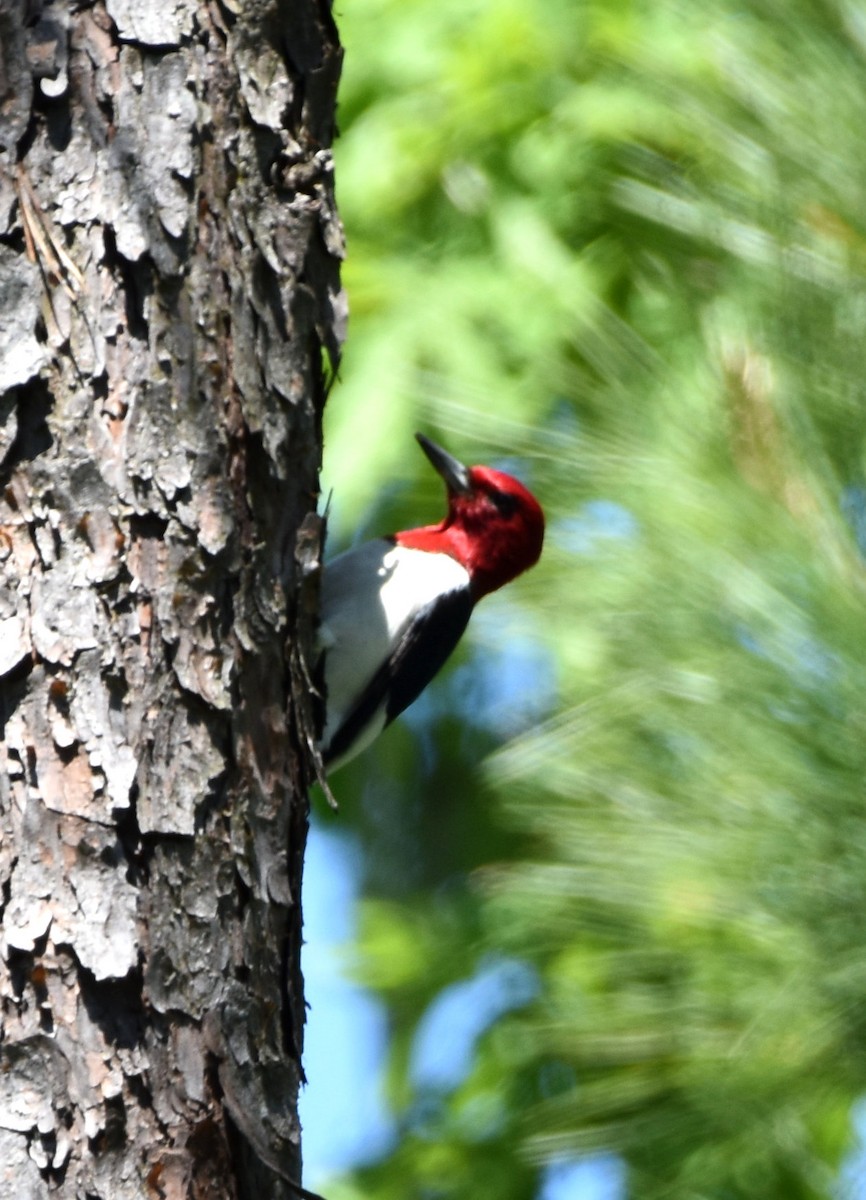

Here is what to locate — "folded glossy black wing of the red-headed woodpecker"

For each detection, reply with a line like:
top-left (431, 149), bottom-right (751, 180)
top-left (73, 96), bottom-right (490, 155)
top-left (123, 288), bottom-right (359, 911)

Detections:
top-left (323, 588), bottom-right (473, 766)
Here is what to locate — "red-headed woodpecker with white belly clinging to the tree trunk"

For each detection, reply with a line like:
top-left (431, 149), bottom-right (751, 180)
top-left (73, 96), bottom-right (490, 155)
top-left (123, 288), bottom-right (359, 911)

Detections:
top-left (319, 433), bottom-right (545, 773)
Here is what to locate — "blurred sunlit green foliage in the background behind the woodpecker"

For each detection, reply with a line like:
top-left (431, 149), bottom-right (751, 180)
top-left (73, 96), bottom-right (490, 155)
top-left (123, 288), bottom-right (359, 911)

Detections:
top-left (316, 0), bottom-right (866, 1200)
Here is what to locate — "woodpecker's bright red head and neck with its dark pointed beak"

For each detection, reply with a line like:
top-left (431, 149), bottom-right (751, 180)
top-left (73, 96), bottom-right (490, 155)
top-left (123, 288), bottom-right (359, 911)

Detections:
top-left (395, 433), bottom-right (545, 600)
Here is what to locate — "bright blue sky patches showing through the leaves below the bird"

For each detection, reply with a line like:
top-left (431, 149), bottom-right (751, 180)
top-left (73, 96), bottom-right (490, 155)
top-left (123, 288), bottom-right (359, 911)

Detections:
top-left (300, 822), bottom-right (625, 1200)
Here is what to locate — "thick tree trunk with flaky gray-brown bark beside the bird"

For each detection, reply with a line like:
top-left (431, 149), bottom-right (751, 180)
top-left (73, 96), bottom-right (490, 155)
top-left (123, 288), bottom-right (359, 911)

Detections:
top-left (0, 0), bottom-right (344, 1200)
